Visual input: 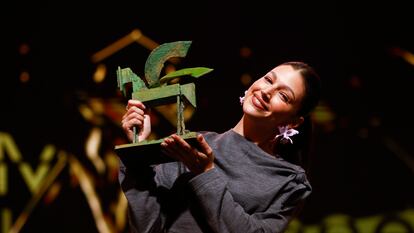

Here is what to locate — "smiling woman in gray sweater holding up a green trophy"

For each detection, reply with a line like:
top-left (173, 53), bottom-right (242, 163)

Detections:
top-left (119, 62), bottom-right (320, 233)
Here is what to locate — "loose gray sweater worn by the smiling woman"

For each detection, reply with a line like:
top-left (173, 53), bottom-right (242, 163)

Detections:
top-left (119, 129), bottom-right (311, 233)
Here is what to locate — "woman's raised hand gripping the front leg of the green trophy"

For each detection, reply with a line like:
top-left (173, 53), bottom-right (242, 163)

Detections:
top-left (121, 99), bottom-right (151, 142)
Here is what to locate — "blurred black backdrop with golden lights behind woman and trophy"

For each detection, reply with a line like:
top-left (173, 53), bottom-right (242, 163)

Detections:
top-left (0, 0), bottom-right (414, 233)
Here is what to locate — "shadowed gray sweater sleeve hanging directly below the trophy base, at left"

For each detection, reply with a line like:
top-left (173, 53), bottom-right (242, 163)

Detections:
top-left (118, 160), bottom-right (163, 232)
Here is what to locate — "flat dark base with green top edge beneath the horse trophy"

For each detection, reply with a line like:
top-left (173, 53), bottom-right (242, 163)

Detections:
top-left (115, 132), bottom-right (198, 167)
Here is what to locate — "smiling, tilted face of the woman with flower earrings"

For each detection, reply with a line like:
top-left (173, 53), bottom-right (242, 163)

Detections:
top-left (243, 65), bottom-right (305, 126)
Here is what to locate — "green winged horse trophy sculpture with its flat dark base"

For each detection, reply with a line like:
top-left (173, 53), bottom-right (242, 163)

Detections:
top-left (115, 41), bottom-right (213, 166)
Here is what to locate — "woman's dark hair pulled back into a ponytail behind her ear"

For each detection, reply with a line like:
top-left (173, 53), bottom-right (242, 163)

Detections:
top-left (276, 61), bottom-right (321, 170)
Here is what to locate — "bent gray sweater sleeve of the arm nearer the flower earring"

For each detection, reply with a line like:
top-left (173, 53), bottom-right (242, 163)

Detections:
top-left (190, 169), bottom-right (311, 233)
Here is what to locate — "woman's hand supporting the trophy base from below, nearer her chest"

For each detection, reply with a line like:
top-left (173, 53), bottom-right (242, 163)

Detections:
top-left (161, 134), bottom-right (214, 175)
